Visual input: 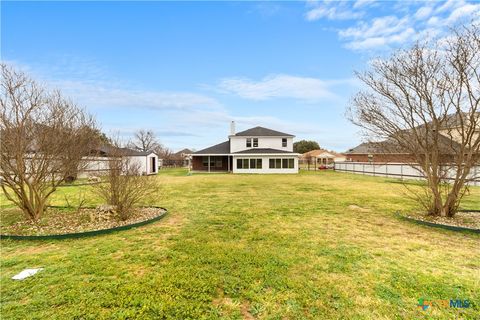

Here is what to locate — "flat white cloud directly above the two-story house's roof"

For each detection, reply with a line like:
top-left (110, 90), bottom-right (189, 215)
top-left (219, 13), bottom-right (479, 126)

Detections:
top-left (218, 74), bottom-right (350, 101)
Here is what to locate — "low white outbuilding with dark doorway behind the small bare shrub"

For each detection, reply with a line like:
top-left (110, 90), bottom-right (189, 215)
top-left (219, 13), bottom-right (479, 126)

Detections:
top-left (79, 146), bottom-right (159, 177)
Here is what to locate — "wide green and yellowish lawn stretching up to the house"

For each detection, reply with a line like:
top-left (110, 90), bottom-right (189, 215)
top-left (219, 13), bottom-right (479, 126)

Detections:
top-left (1, 170), bottom-right (480, 319)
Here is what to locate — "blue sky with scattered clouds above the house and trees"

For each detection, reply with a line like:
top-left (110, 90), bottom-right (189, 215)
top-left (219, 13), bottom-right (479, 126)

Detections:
top-left (1, 0), bottom-right (480, 151)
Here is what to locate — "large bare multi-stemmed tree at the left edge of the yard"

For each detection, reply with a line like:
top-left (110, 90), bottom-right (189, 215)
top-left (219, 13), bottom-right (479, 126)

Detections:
top-left (0, 64), bottom-right (95, 220)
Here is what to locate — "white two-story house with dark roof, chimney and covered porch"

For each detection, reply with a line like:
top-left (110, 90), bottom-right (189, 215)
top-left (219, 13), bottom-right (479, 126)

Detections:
top-left (192, 121), bottom-right (299, 173)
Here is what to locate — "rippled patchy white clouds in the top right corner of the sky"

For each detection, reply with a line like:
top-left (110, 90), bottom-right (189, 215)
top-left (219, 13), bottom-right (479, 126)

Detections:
top-left (305, 0), bottom-right (480, 51)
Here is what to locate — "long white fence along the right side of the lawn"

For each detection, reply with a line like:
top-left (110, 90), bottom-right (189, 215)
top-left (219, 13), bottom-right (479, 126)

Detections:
top-left (334, 162), bottom-right (480, 186)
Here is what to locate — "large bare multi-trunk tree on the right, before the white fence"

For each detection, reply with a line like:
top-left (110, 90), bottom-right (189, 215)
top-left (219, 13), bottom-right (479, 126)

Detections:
top-left (349, 24), bottom-right (480, 217)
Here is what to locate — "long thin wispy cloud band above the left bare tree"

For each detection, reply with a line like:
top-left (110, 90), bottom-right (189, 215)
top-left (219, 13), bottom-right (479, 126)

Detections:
top-left (6, 57), bottom-right (220, 109)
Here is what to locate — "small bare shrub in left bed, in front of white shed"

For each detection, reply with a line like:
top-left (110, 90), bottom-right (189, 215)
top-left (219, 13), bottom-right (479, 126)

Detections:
top-left (94, 139), bottom-right (157, 220)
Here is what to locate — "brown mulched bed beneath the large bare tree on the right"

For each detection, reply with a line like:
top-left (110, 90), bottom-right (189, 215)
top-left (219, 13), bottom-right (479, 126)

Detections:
top-left (405, 210), bottom-right (480, 230)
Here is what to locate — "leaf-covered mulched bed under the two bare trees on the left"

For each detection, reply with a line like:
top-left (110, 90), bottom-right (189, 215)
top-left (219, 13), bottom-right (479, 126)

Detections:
top-left (0, 207), bottom-right (166, 236)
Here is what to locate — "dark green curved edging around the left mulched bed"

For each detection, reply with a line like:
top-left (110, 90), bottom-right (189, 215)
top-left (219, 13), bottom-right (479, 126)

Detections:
top-left (0, 207), bottom-right (168, 240)
